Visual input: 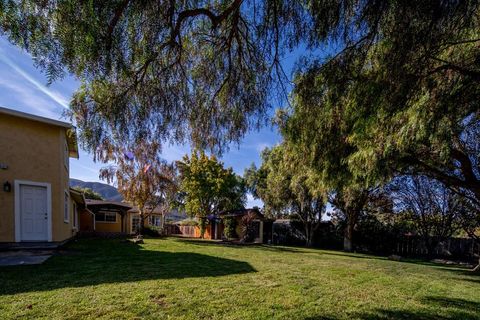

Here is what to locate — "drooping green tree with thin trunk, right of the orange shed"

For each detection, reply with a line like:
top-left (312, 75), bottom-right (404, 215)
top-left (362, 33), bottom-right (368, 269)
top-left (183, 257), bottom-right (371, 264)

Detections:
top-left (244, 144), bottom-right (326, 246)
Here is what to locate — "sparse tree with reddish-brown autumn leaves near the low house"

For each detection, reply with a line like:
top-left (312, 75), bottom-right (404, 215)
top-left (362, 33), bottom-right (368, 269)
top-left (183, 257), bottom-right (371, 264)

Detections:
top-left (100, 141), bottom-right (177, 234)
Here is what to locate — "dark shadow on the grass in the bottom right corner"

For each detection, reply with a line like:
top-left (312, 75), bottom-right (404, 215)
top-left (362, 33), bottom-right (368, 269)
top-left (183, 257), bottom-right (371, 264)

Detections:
top-left (304, 297), bottom-right (480, 320)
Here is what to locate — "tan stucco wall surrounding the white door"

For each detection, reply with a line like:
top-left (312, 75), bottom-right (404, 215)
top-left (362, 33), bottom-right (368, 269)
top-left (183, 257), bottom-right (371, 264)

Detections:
top-left (0, 114), bottom-right (74, 242)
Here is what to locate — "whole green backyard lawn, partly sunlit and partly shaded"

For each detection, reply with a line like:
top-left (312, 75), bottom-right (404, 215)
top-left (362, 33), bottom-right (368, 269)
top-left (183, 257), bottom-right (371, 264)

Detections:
top-left (0, 239), bottom-right (480, 320)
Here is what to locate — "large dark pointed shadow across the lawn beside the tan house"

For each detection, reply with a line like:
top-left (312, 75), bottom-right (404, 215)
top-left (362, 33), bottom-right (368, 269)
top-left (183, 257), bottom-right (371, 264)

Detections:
top-left (0, 239), bottom-right (256, 295)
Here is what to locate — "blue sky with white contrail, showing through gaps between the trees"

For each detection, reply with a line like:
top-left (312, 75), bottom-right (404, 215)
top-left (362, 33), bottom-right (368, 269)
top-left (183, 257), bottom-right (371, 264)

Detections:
top-left (0, 37), bottom-right (296, 206)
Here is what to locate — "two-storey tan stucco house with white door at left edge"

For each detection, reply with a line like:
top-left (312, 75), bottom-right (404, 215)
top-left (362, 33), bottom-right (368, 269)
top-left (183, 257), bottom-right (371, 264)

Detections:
top-left (0, 107), bottom-right (81, 243)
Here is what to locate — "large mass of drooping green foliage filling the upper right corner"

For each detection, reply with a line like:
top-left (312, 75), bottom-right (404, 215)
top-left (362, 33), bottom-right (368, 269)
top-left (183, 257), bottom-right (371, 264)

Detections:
top-left (282, 1), bottom-right (480, 200)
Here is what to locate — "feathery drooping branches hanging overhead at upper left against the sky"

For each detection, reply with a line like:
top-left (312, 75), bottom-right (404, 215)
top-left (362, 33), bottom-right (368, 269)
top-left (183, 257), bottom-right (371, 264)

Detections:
top-left (0, 0), bottom-right (302, 153)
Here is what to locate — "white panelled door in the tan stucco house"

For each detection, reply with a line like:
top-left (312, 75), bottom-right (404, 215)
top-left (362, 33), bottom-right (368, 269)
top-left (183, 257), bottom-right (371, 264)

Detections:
top-left (20, 184), bottom-right (48, 241)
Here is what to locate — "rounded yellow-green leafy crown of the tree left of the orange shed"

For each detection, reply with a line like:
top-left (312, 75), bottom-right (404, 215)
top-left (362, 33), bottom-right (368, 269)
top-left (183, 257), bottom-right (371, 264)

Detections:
top-left (177, 151), bottom-right (246, 217)
